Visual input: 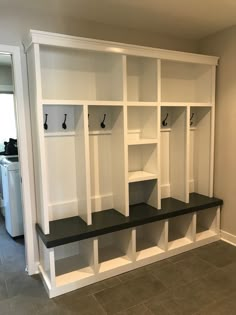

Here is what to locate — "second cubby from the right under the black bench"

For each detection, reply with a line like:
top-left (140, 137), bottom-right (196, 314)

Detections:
top-left (168, 213), bottom-right (194, 250)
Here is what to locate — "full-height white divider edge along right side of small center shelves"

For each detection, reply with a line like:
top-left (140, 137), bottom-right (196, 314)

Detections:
top-left (157, 59), bottom-right (161, 211)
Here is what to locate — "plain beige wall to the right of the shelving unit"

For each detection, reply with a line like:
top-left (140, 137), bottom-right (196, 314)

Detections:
top-left (200, 26), bottom-right (236, 241)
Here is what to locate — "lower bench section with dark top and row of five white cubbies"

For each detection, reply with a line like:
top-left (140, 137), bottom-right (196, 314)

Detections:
top-left (36, 193), bottom-right (223, 298)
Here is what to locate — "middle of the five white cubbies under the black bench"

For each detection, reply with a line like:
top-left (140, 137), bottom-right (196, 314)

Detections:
top-left (136, 221), bottom-right (167, 260)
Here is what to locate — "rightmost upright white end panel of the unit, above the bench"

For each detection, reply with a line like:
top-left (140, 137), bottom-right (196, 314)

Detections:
top-left (209, 66), bottom-right (216, 197)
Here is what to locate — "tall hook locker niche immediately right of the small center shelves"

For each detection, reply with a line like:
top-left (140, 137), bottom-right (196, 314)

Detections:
top-left (160, 106), bottom-right (188, 202)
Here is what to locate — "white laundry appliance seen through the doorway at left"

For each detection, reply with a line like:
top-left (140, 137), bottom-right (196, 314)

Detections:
top-left (0, 157), bottom-right (24, 237)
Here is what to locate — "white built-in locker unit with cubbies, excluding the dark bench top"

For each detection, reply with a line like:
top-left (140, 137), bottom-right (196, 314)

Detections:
top-left (25, 31), bottom-right (219, 297)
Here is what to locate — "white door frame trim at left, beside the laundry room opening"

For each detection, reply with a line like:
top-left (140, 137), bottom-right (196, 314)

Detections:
top-left (0, 45), bottom-right (37, 275)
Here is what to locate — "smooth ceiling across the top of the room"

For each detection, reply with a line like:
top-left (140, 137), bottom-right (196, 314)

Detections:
top-left (1, 0), bottom-right (236, 40)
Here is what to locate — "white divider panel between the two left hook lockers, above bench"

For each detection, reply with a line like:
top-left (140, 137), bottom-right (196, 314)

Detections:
top-left (74, 105), bottom-right (92, 225)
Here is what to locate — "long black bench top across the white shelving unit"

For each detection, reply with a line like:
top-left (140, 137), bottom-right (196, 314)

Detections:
top-left (36, 193), bottom-right (223, 248)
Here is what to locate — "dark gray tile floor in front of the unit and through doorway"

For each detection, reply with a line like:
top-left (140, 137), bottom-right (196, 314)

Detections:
top-left (0, 215), bottom-right (236, 315)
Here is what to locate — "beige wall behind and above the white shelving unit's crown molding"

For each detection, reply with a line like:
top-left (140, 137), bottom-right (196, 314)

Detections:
top-left (0, 8), bottom-right (197, 274)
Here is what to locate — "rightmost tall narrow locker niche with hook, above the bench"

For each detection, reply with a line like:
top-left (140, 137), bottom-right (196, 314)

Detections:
top-left (189, 107), bottom-right (213, 197)
